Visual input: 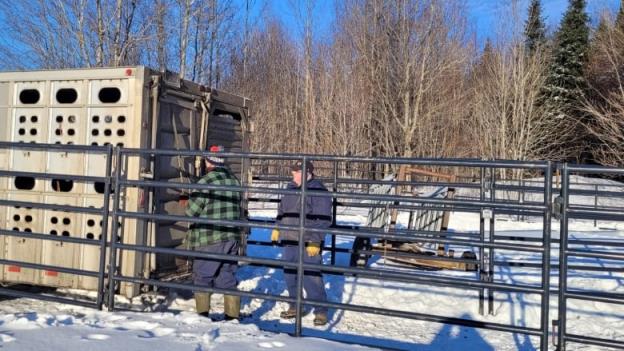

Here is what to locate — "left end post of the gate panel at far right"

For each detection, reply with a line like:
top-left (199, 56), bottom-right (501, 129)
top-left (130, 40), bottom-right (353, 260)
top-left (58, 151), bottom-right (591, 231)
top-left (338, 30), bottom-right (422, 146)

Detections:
top-left (557, 163), bottom-right (570, 351)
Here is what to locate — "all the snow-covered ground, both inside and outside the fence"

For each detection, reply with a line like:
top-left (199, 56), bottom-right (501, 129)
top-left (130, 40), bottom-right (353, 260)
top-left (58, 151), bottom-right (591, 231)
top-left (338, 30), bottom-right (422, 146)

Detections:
top-left (0, 177), bottom-right (624, 351)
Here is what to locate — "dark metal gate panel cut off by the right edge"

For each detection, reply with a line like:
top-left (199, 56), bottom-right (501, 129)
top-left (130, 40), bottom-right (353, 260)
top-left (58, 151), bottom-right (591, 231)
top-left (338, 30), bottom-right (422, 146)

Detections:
top-left (555, 164), bottom-right (624, 351)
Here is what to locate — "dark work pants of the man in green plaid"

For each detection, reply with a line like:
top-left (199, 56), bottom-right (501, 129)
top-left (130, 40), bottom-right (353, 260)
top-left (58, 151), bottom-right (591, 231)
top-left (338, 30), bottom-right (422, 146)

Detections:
top-left (193, 240), bottom-right (238, 289)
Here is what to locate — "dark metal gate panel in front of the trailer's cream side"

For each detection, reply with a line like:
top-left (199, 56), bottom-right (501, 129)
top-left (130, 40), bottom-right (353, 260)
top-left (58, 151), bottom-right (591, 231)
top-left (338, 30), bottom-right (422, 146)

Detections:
top-left (0, 142), bottom-right (113, 309)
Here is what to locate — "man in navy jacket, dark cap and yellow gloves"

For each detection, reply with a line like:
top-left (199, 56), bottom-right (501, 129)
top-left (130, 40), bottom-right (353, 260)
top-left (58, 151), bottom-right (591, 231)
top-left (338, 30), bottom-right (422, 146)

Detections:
top-left (271, 161), bottom-right (332, 325)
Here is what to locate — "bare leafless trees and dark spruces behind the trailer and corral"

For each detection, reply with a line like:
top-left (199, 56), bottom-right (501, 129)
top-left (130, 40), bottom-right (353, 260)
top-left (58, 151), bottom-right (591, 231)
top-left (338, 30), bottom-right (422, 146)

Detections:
top-left (0, 0), bottom-right (624, 166)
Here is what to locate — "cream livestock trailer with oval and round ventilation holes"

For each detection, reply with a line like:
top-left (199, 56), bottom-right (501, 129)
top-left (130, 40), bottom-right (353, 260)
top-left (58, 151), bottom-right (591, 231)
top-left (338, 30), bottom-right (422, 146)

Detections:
top-left (0, 66), bottom-right (251, 296)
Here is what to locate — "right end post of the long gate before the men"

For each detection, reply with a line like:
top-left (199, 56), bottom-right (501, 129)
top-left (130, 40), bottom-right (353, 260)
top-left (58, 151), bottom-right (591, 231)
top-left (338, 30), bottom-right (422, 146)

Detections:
top-left (540, 162), bottom-right (552, 350)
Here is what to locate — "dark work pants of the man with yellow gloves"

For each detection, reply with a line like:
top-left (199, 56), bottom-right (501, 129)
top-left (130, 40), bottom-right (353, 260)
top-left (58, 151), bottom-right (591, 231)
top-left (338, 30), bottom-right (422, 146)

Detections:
top-left (283, 245), bottom-right (327, 313)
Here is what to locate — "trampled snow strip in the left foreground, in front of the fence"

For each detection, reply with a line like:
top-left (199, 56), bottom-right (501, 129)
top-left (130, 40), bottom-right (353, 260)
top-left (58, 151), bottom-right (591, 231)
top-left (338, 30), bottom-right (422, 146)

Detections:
top-left (0, 299), bottom-right (376, 351)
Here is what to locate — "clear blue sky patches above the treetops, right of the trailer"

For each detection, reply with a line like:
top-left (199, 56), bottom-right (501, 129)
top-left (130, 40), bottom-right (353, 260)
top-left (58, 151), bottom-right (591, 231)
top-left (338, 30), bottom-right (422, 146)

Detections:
top-left (260, 0), bottom-right (620, 43)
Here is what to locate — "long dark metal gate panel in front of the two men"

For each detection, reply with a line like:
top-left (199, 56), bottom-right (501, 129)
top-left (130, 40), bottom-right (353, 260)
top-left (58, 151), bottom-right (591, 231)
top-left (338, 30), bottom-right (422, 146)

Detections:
top-left (109, 148), bottom-right (552, 350)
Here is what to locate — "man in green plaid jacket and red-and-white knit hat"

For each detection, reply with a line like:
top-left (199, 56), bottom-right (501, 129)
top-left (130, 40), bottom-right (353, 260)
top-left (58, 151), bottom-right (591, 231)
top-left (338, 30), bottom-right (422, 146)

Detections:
top-left (186, 145), bottom-right (241, 319)
